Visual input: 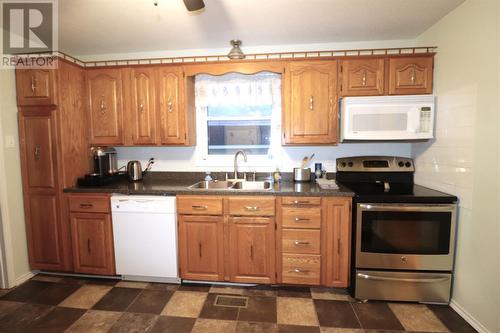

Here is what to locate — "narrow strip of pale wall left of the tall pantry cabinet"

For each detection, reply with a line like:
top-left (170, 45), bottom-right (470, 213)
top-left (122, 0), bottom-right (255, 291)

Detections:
top-left (0, 69), bottom-right (30, 286)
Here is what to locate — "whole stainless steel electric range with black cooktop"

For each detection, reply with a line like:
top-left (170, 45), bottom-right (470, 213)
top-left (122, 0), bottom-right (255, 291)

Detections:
top-left (337, 156), bottom-right (457, 303)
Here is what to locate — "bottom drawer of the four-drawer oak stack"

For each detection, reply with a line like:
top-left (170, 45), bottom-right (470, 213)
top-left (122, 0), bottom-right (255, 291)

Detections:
top-left (282, 254), bottom-right (321, 285)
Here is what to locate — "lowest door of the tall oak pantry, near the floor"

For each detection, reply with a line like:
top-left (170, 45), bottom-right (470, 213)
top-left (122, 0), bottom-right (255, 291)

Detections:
top-left (24, 194), bottom-right (63, 270)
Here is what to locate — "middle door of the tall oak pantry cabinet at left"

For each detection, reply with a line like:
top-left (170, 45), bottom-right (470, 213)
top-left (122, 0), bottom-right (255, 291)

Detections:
top-left (19, 109), bottom-right (56, 189)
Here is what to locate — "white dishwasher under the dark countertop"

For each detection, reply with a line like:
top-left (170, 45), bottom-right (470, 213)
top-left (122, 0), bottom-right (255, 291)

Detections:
top-left (111, 194), bottom-right (180, 283)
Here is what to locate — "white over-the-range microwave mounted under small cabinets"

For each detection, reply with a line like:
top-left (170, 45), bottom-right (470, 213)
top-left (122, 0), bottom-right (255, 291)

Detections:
top-left (340, 95), bottom-right (435, 141)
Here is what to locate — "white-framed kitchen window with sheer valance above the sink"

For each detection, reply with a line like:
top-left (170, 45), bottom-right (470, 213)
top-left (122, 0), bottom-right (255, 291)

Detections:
top-left (195, 72), bottom-right (281, 166)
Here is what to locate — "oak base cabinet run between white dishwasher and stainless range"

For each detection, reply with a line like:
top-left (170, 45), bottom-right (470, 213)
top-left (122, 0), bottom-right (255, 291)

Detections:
top-left (177, 195), bottom-right (351, 287)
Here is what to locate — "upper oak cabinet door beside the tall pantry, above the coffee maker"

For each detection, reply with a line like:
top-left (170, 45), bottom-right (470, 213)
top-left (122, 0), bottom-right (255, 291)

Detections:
top-left (87, 69), bottom-right (123, 145)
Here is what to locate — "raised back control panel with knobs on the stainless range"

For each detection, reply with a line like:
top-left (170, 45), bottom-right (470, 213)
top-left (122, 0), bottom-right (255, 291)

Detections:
top-left (337, 156), bottom-right (415, 172)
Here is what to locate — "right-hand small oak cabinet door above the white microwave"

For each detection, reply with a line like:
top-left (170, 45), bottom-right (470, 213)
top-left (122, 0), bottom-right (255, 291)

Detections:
top-left (389, 56), bottom-right (434, 95)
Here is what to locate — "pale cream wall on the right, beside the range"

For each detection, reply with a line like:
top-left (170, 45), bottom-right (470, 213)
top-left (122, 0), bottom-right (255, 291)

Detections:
top-left (412, 0), bottom-right (500, 332)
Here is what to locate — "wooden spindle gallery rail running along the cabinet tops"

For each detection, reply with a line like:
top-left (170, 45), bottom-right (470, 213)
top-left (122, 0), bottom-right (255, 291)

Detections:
top-left (49, 46), bottom-right (437, 67)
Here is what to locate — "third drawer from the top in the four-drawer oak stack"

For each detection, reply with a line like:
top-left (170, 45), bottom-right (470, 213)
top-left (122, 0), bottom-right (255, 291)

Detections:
top-left (282, 229), bottom-right (320, 254)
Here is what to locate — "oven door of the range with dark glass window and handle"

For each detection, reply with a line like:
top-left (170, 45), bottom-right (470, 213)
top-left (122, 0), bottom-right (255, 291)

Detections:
top-left (356, 203), bottom-right (456, 271)
